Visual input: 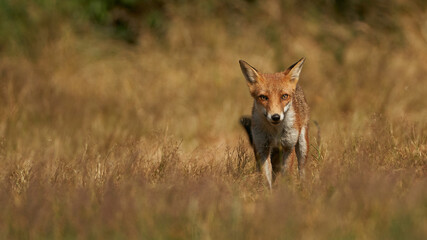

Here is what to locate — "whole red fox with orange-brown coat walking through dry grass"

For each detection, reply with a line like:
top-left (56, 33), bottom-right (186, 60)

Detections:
top-left (239, 58), bottom-right (309, 189)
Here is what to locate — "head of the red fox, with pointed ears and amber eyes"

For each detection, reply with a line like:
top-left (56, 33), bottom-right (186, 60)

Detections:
top-left (239, 58), bottom-right (305, 125)
